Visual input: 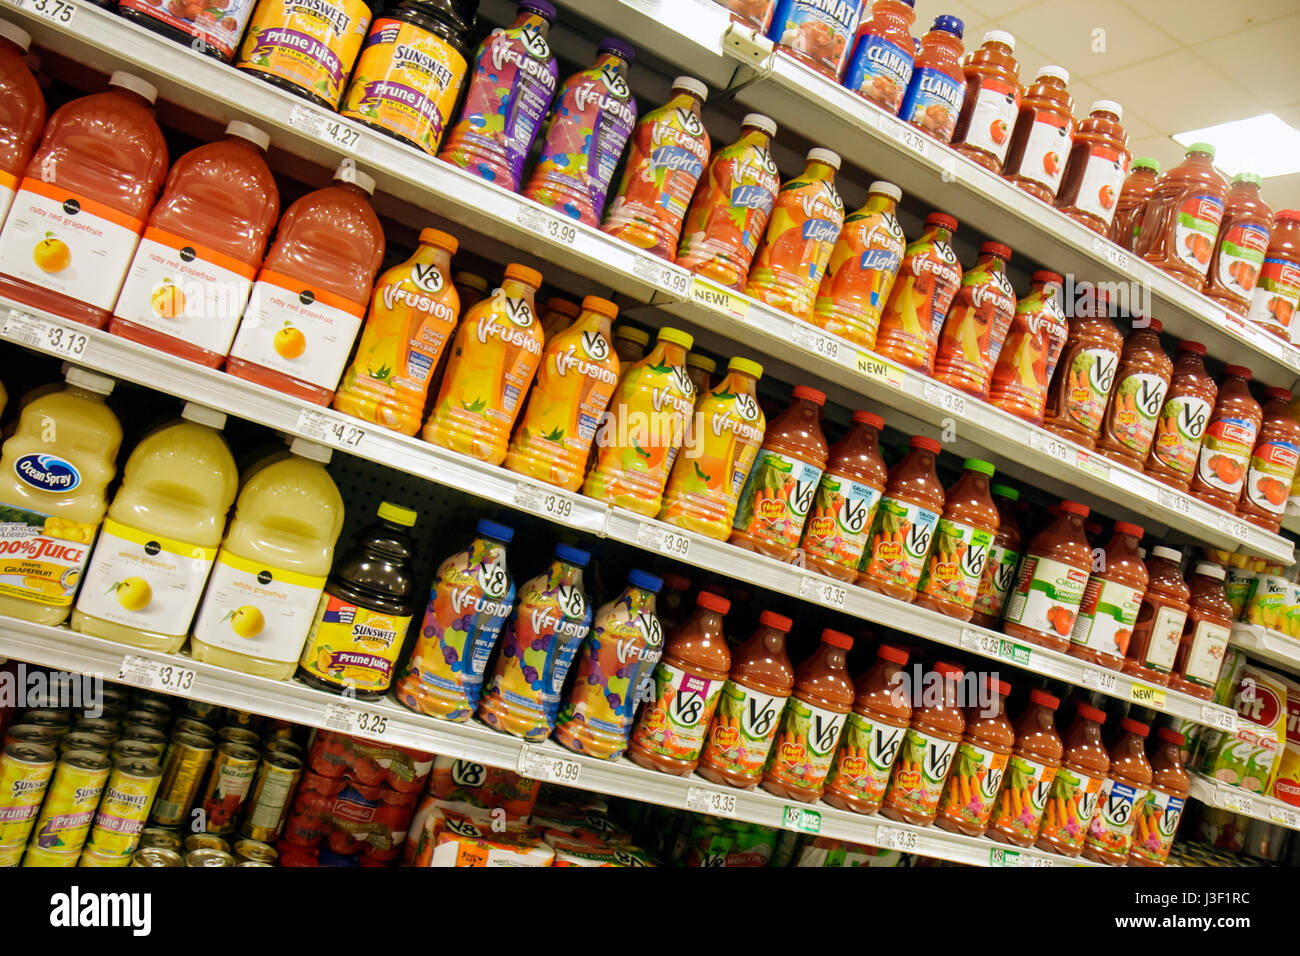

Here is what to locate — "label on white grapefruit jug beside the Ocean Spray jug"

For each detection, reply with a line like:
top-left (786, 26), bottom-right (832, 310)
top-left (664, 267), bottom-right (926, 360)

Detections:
top-left (77, 518), bottom-right (217, 636)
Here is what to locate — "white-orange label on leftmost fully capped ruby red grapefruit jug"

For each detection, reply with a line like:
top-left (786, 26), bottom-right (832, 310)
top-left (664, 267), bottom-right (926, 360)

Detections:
top-left (0, 178), bottom-right (144, 312)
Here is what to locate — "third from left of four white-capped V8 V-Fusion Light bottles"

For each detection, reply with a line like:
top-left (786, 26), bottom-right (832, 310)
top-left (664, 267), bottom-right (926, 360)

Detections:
top-left (745, 150), bottom-right (844, 319)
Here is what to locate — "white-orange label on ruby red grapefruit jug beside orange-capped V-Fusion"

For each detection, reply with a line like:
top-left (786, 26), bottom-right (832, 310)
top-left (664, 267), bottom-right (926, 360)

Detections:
top-left (230, 269), bottom-right (365, 392)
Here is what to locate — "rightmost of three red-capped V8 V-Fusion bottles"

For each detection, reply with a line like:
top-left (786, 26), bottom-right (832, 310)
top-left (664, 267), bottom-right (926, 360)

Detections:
top-left (988, 269), bottom-right (1071, 425)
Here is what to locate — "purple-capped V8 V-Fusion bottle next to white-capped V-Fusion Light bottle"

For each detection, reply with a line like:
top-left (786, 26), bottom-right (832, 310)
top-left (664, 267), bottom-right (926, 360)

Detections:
top-left (524, 36), bottom-right (637, 228)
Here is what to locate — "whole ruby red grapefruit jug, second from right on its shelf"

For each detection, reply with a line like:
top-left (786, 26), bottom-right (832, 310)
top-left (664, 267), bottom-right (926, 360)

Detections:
top-left (108, 121), bottom-right (280, 368)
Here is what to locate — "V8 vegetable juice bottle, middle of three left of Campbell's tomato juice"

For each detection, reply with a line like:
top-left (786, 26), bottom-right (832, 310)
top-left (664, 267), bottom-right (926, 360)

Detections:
top-left (1096, 319), bottom-right (1174, 471)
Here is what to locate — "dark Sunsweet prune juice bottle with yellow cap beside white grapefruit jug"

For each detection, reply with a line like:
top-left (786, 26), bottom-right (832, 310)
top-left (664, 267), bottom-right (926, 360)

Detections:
top-left (298, 501), bottom-right (416, 700)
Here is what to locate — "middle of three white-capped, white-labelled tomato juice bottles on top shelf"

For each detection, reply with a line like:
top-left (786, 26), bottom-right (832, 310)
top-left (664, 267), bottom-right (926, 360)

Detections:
top-left (1002, 66), bottom-right (1074, 203)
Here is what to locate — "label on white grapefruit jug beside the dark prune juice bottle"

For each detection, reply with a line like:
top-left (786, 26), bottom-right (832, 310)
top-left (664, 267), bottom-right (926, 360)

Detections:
top-left (194, 550), bottom-right (325, 663)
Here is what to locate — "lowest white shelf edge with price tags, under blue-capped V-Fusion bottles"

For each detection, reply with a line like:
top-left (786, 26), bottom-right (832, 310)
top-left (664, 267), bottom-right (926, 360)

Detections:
top-left (0, 617), bottom-right (1091, 866)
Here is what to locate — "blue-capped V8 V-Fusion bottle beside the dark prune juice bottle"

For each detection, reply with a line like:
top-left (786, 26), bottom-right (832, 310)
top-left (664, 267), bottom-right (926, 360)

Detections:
top-left (394, 518), bottom-right (515, 723)
